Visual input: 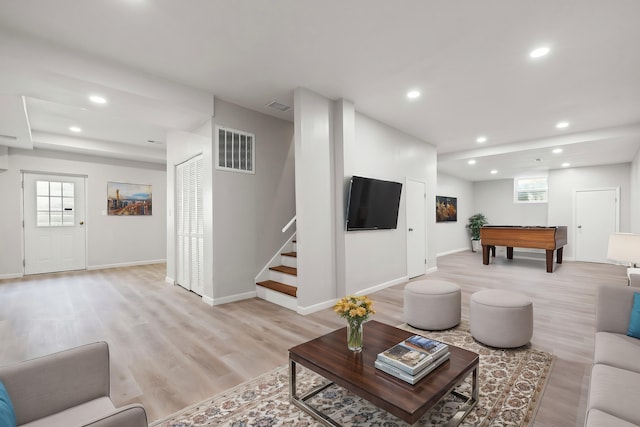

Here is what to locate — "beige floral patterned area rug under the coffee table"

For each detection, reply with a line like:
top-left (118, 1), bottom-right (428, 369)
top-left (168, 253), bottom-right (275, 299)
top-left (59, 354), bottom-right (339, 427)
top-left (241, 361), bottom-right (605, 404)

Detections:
top-left (151, 321), bottom-right (553, 427)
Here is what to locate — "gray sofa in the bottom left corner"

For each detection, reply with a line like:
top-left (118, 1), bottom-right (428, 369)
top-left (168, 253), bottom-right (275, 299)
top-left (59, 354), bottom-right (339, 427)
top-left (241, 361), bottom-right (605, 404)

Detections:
top-left (0, 342), bottom-right (147, 427)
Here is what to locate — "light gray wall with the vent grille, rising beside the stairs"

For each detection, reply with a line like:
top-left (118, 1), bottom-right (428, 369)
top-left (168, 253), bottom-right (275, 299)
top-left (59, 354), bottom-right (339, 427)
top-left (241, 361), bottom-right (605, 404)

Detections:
top-left (212, 98), bottom-right (296, 304)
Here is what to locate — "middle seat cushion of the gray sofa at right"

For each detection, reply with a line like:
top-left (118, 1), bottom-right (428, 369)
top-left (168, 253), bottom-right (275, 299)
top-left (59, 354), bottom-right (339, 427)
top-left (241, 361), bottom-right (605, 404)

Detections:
top-left (588, 364), bottom-right (640, 424)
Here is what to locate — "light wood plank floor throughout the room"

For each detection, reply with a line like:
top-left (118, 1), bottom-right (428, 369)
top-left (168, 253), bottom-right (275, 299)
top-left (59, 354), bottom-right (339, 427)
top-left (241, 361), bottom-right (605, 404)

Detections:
top-left (0, 252), bottom-right (626, 427)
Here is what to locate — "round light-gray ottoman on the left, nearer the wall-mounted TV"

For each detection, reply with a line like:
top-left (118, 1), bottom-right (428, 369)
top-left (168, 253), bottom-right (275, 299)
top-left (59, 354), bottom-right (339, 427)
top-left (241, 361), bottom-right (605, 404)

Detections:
top-left (404, 280), bottom-right (461, 331)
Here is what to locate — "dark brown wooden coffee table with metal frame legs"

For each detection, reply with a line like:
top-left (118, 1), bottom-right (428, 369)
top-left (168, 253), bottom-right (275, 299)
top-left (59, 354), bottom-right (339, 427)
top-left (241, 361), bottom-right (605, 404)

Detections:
top-left (289, 321), bottom-right (479, 426)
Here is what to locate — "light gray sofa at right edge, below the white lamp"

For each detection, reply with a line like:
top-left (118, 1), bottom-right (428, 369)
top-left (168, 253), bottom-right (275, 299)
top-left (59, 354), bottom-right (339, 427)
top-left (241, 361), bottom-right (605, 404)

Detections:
top-left (585, 286), bottom-right (640, 427)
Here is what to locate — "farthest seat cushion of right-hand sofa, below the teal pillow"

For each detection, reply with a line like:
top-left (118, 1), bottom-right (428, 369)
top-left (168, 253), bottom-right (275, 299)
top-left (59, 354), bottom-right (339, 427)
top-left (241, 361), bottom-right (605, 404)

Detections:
top-left (593, 332), bottom-right (640, 373)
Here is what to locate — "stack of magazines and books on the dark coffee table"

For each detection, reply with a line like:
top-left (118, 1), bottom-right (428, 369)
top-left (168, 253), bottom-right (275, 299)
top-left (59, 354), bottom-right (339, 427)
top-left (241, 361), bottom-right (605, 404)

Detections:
top-left (377, 337), bottom-right (449, 375)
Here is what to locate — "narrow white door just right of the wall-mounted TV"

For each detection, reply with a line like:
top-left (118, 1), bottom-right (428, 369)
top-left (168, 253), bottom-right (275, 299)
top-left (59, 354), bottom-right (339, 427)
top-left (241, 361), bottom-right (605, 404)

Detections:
top-left (405, 179), bottom-right (427, 277)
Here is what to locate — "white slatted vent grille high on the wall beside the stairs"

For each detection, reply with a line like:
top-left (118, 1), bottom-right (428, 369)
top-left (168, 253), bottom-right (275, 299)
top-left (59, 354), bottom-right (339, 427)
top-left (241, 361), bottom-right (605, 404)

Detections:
top-left (216, 126), bottom-right (255, 173)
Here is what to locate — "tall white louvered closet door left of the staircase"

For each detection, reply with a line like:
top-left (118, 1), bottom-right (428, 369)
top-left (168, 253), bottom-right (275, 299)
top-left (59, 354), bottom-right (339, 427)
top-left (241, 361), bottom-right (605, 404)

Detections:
top-left (176, 156), bottom-right (204, 295)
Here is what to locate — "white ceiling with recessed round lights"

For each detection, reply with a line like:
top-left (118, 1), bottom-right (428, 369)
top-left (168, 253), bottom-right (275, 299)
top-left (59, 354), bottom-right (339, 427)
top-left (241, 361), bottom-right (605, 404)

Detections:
top-left (0, 0), bottom-right (640, 181)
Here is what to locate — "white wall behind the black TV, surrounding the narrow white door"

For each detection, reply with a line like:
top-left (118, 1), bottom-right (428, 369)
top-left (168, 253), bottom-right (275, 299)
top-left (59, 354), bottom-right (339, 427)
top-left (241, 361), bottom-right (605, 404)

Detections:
top-left (340, 113), bottom-right (436, 293)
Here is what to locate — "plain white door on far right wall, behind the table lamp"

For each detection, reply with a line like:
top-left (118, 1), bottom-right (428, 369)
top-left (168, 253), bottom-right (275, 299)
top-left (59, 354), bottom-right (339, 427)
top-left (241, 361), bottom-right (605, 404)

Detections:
top-left (575, 188), bottom-right (619, 263)
